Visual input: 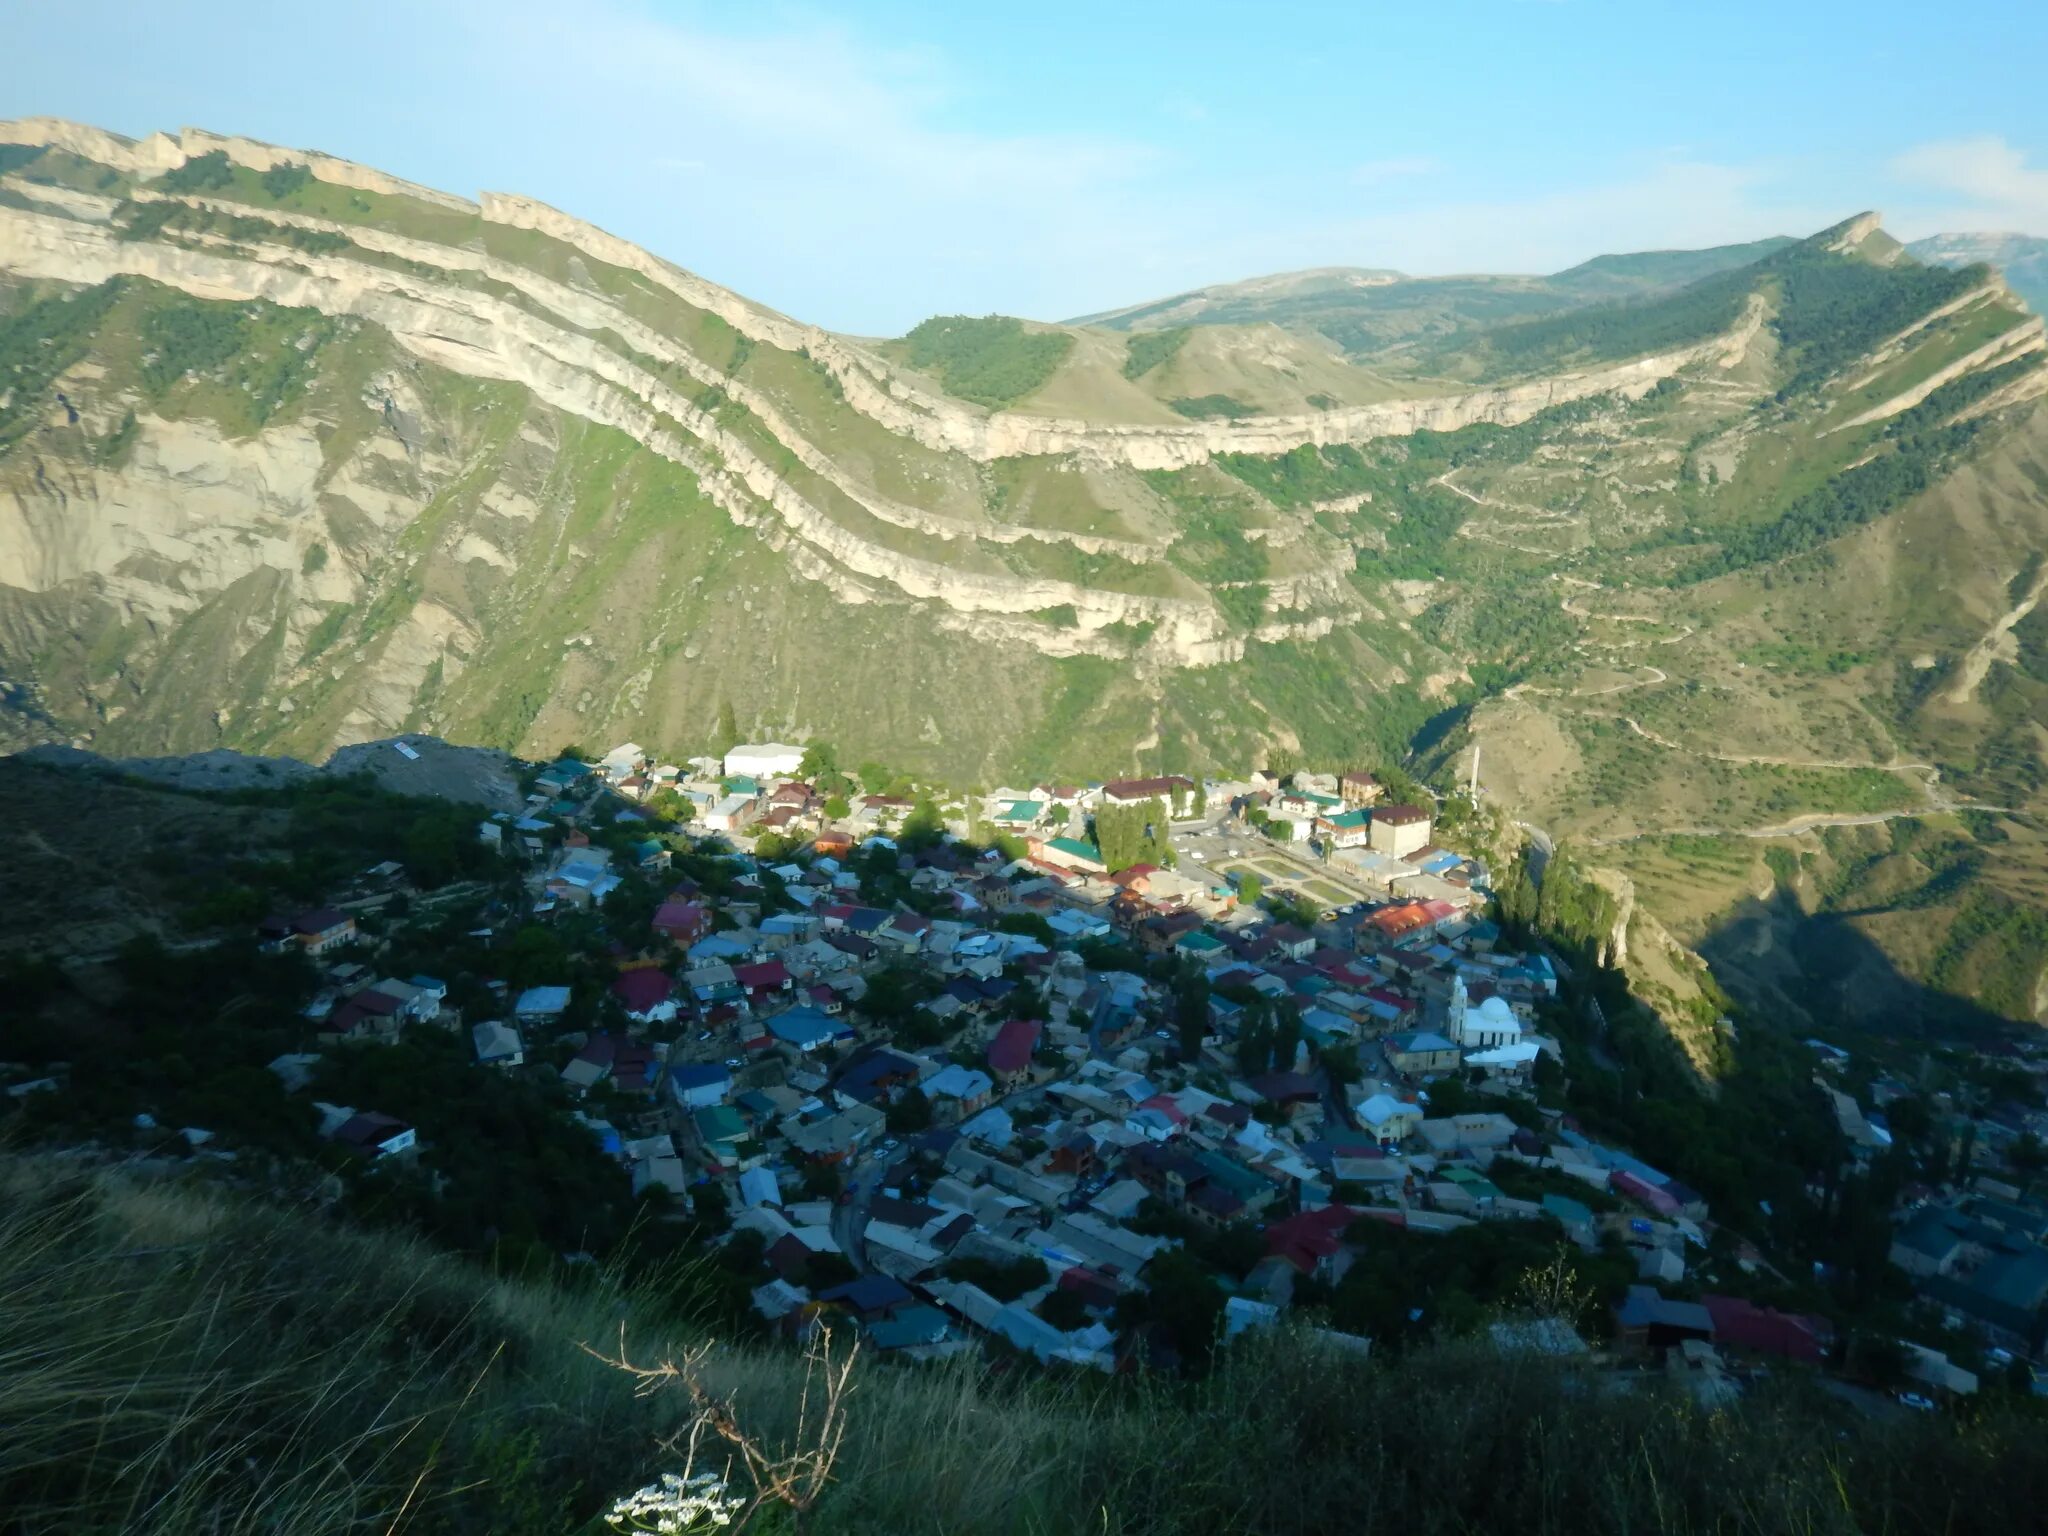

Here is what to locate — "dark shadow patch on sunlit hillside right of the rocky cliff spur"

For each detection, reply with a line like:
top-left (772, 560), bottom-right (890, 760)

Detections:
top-left (1694, 887), bottom-right (2021, 1042)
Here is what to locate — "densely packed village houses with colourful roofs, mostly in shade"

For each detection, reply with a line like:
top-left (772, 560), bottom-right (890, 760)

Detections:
top-left (155, 743), bottom-right (2048, 1407)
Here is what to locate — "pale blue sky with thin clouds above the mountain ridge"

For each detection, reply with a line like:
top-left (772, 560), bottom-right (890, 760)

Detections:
top-left (16, 0), bottom-right (2048, 336)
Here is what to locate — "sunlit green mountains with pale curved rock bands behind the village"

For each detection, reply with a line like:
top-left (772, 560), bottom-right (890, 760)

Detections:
top-left (0, 121), bottom-right (2048, 1036)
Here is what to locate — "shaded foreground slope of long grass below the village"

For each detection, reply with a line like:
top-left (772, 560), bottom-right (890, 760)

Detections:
top-left (16, 1155), bottom-right (2048, 1536)
